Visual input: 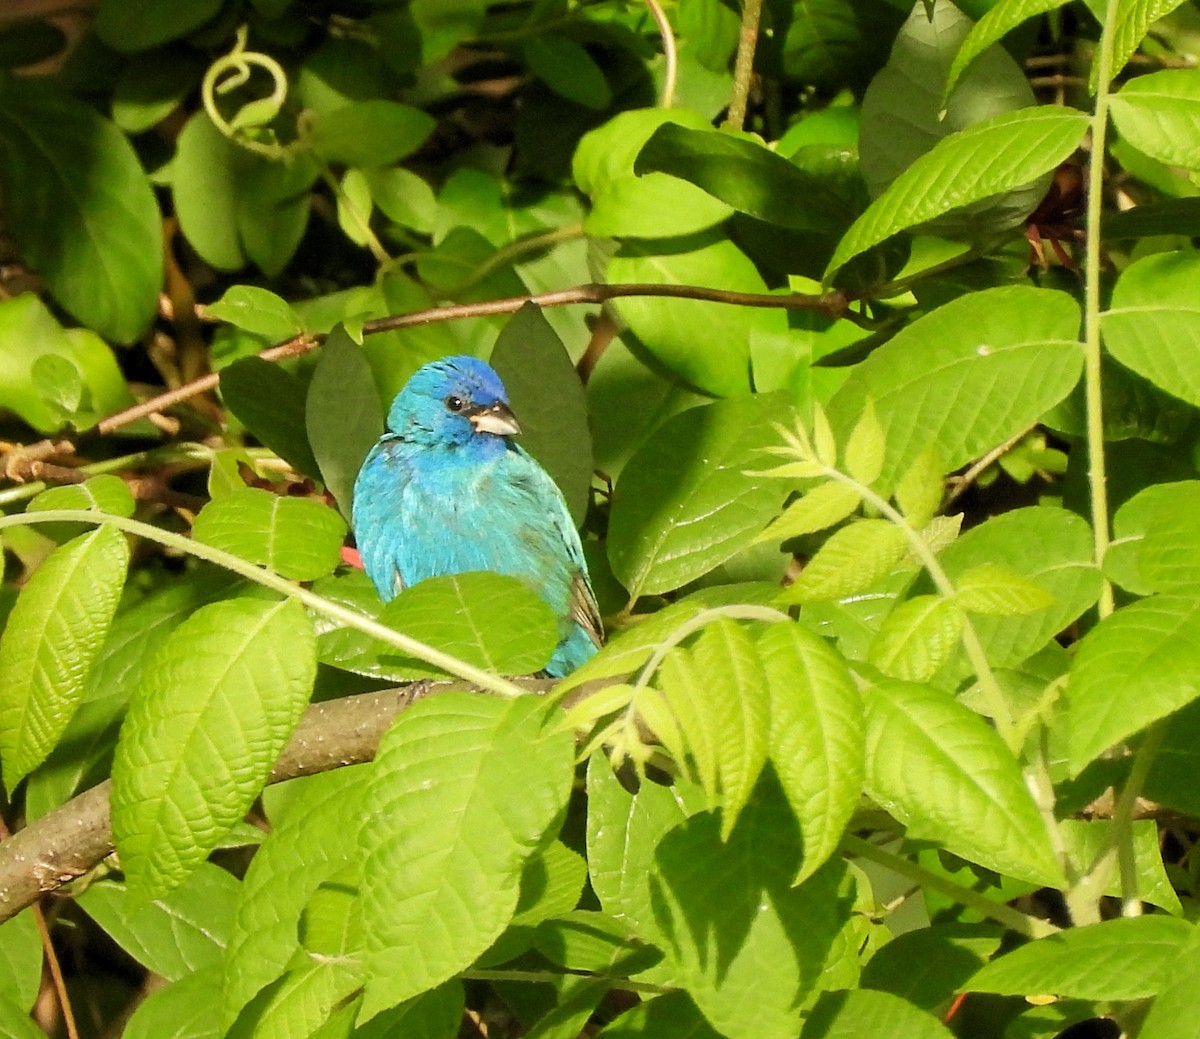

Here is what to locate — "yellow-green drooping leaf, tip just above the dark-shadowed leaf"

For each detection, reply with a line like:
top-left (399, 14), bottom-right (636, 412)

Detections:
top-left (659, 618), bottom-right (770, 840)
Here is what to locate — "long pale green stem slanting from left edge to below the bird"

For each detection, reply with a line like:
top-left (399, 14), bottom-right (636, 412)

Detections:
top-left (0, 509), bottom-right (526, 698)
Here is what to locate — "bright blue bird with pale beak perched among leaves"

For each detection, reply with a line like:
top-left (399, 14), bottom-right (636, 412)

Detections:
top-left (353, 355), bottom-right (601, 678)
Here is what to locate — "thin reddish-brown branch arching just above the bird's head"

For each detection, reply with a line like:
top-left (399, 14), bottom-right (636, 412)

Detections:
top-left (95, 283), bottom-right (848, 434)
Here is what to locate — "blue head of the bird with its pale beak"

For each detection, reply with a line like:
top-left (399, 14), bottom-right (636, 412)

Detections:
top-left (388, 355), bottom-right (521, 445)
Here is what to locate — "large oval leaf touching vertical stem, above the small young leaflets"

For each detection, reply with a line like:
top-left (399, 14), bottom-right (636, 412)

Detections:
top-left (829, 286), bottom-right (1084, 487)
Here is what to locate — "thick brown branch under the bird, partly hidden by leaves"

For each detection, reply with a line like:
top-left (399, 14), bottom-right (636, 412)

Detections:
top-left (0, 679), bottom-right (551, 923)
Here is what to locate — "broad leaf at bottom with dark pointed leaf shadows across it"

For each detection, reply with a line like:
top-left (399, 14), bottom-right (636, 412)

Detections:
top-left (641, 769), bottom-right (850, 1039)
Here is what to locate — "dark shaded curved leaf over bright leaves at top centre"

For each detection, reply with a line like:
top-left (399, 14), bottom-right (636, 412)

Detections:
top-left (634, 122), bottom-right (851, 234)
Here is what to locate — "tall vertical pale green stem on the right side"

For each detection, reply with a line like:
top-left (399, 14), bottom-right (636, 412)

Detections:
top-left (1084, 0), bottom-right (1121, 620)
